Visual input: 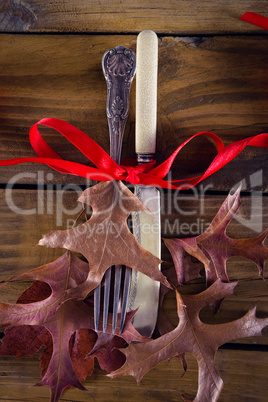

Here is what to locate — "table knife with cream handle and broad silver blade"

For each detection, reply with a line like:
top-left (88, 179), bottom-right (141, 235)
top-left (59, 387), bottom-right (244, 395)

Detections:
top-left (128, 30), bottom-right (161, 337)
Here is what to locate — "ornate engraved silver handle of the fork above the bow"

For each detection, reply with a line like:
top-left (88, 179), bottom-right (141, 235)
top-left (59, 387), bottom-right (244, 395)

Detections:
top-left (102, 46), bottom-right (136, 164)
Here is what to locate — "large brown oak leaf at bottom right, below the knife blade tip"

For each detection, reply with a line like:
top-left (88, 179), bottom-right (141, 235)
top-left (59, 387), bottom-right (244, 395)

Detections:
top-left (109, 279), bottom-right (268, 402)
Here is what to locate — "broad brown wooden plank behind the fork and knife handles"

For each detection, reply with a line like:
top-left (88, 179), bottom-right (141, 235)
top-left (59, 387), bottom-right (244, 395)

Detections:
top-left (0, 35), bottom-right (268, 190)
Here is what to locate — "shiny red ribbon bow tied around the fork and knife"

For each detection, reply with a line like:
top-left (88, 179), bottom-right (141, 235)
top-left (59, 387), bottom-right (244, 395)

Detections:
top-left (0, 118), bottom-right (268, 189)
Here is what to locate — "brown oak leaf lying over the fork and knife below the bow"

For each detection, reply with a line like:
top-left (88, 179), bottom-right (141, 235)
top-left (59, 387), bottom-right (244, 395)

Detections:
top-left (39, 181), bottom-right (170, 299)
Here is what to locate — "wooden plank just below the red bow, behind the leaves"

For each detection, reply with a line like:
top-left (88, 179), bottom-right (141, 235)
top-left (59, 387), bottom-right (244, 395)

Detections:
top-left (0, 189), bottom-right (268, 344)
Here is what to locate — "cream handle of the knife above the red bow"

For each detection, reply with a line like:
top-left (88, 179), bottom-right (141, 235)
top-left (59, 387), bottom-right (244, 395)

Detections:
top-left (135, 30), bottom-right (158, 162)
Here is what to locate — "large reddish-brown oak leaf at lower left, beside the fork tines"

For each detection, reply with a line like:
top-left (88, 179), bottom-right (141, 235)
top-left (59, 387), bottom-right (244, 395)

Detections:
top-left (0, 251), bottom-right (147, 402)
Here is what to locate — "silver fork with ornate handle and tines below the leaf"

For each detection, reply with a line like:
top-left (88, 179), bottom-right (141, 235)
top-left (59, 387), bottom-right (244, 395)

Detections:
top-left (94, 46), bottom-right (136, 333)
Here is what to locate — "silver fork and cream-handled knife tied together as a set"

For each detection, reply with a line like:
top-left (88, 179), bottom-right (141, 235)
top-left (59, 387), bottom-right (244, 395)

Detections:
top-left (94, 30), bottom-right (161, 337)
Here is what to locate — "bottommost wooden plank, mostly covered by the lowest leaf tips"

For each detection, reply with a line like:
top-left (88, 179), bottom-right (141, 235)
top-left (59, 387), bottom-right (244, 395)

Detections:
top-left (0, 350), bottom-right (268, 402)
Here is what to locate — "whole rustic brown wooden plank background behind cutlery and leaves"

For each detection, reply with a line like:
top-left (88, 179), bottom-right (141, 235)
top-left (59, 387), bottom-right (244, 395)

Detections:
top-left (0, 0), bottom-right (268, 402)
